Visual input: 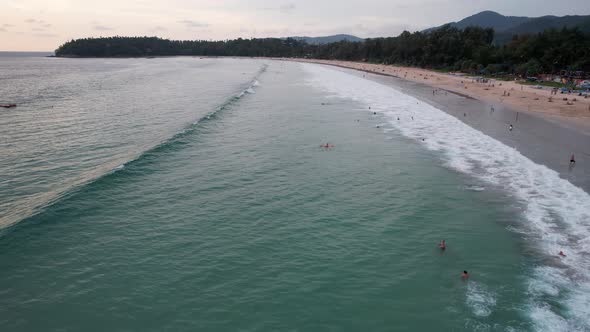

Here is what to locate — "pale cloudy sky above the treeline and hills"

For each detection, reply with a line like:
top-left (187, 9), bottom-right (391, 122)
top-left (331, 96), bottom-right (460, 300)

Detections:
top-left (0, 0), bottom-right (590, 51)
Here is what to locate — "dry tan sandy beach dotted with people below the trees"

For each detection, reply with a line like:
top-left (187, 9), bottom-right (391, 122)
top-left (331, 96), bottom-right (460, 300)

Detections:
top-left (294, 59), bottom-right (590, 131)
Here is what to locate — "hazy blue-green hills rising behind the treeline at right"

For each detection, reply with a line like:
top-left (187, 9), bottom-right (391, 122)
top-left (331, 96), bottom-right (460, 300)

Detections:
top-left (424, 11), bottom-right (590, 43)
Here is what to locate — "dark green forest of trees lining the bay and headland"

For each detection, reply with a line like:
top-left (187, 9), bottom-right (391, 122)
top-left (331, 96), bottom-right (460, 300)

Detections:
top-left (55, 25), bottom-right (590, 76)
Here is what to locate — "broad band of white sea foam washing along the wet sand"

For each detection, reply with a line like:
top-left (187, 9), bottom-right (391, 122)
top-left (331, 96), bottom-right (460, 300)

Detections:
top-left (302, 64), bottom-right (590, 331)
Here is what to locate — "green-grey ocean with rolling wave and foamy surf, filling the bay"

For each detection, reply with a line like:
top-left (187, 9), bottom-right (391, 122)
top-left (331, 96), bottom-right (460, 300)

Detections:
top-left (0, 57), bottom-right (590, 331)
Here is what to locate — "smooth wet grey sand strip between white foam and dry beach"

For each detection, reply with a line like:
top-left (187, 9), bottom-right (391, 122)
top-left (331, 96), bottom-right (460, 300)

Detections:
top-left (298, 60), bottom-right (590, 193)
